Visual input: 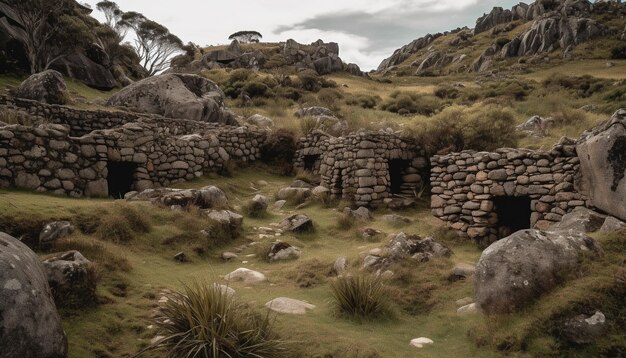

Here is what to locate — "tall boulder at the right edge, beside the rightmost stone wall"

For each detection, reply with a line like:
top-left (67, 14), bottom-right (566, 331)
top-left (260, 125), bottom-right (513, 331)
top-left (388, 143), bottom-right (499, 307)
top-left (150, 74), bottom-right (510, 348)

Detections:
top-left (576, 109), bottom-right (626, 220)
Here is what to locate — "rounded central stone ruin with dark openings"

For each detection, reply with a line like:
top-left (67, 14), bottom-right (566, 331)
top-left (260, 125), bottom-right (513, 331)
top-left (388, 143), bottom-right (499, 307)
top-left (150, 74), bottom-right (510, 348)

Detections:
top-left (295, 131), bottom-right (429, 208)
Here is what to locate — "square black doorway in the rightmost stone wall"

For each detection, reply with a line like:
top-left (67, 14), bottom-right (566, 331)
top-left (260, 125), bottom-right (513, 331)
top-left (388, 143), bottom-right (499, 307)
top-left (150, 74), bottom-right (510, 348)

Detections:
top-left (493, 196), bottom-right (531, 237)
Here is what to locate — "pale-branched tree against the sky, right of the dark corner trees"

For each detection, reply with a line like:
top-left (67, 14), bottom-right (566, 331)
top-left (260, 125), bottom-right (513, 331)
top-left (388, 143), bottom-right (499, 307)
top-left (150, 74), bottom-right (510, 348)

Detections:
top-left (120, 11), bottom-right (183, 76)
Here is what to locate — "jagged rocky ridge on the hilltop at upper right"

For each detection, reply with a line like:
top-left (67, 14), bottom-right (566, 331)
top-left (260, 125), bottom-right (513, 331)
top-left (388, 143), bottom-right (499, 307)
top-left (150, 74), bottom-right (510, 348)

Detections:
top-left (377, 0), bottom-right (626, 75)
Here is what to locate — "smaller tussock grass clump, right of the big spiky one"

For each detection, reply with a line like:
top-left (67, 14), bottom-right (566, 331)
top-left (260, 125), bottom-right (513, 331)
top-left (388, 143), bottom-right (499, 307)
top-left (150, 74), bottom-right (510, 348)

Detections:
top-left (330, 275), bottom-right (393, 319)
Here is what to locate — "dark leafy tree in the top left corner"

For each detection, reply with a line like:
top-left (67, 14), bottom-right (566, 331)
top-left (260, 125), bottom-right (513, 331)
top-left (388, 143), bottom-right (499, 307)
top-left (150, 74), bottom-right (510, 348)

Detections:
top-left (0, 0), bottom-right (91, 73)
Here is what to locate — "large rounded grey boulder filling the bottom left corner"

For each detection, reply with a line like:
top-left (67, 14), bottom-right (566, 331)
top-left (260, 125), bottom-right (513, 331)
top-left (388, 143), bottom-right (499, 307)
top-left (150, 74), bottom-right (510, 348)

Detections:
top-left (0, 232), bottom-right (67, 358)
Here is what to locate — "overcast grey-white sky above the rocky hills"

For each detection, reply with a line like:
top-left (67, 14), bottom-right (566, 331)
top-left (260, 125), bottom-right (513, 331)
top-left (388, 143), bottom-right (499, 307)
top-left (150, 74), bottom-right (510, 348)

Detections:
top-left (85, 0), bottom-right (519, 70)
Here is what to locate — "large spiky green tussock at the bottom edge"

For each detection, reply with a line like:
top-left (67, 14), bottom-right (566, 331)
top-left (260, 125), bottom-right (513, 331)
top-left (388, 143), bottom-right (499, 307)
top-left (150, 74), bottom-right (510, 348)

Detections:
top-left (146, 282), bottom-right (287, 358)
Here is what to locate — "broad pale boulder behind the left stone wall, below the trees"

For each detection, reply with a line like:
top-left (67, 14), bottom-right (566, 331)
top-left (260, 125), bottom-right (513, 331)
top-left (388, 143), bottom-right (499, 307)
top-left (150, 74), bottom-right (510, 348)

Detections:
top-left (107, 74), bottom-right (238, 125)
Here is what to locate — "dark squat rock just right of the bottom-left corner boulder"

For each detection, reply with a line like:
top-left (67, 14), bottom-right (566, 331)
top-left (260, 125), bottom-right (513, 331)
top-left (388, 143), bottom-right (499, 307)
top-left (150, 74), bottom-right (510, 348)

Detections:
top-left (43, 251), bottom-right (97, 308)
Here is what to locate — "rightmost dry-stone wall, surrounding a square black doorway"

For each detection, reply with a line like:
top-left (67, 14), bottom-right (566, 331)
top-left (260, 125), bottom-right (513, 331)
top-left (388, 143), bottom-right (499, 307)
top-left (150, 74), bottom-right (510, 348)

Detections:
top-left (430, 142), bottom-right (586, 242)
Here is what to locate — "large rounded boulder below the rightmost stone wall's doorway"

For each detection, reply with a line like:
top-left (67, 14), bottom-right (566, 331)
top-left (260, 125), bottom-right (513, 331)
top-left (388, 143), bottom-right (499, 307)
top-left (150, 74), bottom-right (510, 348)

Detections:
top-left (475, 230), bottom-right (602, 313)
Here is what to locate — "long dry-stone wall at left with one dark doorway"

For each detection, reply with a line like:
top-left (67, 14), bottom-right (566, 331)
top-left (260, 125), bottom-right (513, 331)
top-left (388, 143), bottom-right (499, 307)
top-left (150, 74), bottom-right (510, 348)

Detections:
top-left (0, 97), bottom-right (266, 197)
